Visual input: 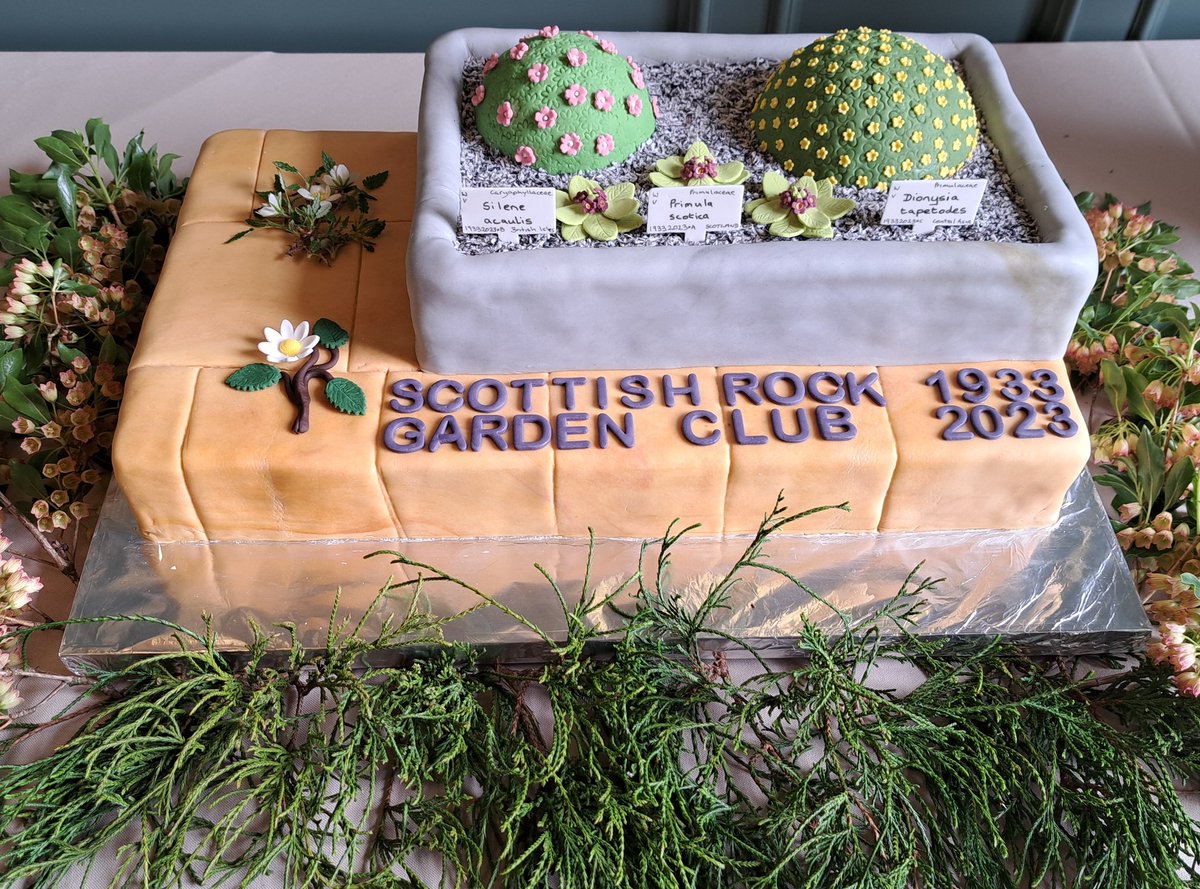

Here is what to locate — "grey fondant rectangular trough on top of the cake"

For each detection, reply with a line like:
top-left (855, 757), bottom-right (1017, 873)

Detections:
top-left (408, 29), bottom-right (1097, 373)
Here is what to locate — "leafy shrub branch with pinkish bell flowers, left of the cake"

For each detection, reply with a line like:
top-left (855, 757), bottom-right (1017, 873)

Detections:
top-left (0, 119), bottom-right (186, 717)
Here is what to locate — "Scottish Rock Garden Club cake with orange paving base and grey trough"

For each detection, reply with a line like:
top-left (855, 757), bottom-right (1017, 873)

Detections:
top-left (114, 29), bottom-right (1096, 542)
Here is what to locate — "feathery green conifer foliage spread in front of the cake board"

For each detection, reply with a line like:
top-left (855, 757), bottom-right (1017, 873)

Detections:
top-left (0, 499), bottom-right (1200, 889)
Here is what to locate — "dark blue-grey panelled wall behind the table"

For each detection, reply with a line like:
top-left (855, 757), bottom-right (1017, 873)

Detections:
top-left (0, 0), bottom-right (1200, 53)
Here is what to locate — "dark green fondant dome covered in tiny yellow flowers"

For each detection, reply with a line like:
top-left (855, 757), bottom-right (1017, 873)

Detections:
top-left (749, 28), bottom-right (979, 190)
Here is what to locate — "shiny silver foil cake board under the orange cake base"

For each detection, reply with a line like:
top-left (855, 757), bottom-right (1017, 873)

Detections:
top-left (60, 473), bottom-right (1150, 672)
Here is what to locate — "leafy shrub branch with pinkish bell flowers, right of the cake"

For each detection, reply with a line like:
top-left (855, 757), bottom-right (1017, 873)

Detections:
top-left (1067, 194), bottom-right (1200, 697)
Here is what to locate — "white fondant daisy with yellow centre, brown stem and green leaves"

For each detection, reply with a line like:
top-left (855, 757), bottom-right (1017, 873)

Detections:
top-left (226, 318), bottom-right (367, 434)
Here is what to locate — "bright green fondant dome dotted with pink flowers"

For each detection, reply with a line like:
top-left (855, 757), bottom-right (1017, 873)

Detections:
top-left (470, 25), bottom-right (658, 173)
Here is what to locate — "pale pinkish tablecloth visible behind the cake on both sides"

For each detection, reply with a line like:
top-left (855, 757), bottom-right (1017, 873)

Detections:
top-left (0, 41), bottom-right (1200, 883)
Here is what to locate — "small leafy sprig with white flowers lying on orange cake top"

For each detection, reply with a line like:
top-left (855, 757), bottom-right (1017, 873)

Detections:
top-left (227, 151), bottom-right (388, 264)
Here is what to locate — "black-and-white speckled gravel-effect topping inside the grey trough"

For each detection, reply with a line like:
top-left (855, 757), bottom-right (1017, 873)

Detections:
top-left (458, 59), bottom-right (1042, 256)
